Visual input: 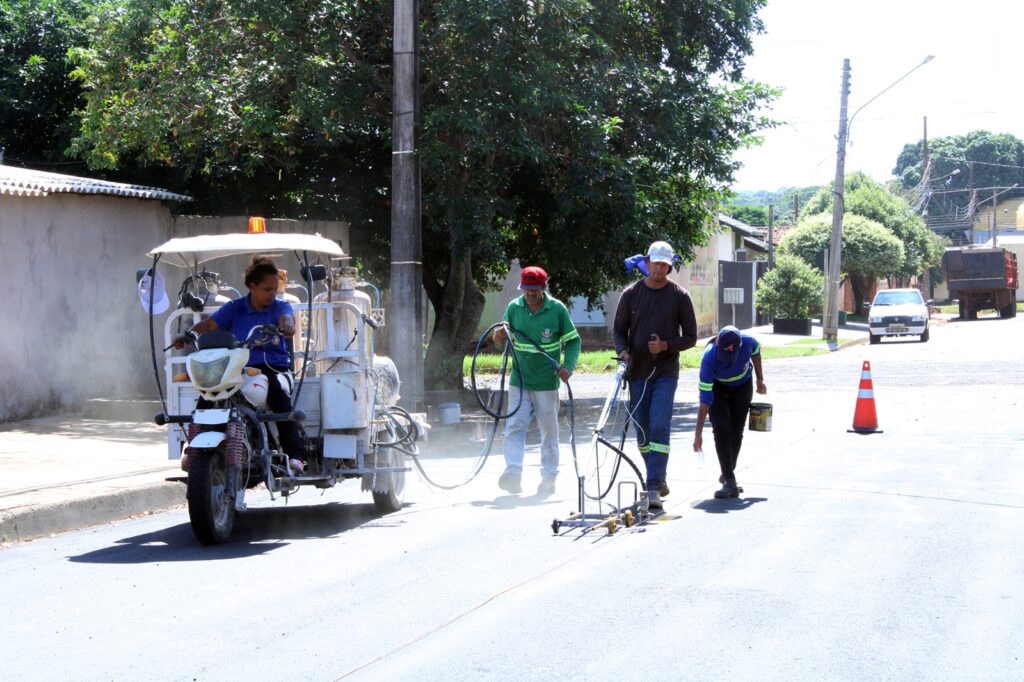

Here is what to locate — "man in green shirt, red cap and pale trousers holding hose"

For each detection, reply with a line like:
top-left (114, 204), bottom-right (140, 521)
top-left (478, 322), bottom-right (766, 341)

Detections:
top-left (493, 266), bottom-right (581, 496)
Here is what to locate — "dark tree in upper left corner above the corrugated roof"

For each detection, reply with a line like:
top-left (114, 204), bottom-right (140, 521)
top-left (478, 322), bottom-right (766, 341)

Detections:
top-left (0, 0), bottom-right (93, 168)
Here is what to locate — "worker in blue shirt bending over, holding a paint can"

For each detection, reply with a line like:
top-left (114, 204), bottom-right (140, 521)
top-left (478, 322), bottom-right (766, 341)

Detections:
top-left (693, 326), bottom-right (768, 493)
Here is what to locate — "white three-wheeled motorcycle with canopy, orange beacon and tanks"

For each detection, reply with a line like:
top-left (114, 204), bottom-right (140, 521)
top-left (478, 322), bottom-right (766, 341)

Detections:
top-left (147, 227), bottom-right (419, 545)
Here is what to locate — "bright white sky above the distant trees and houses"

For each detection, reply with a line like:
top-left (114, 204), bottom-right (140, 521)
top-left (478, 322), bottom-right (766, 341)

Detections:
top-left (733, 0), bottom-right (1024, 190)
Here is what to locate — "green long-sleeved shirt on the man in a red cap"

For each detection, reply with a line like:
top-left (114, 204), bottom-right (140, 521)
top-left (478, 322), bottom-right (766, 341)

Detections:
top-left (503, 293), bottom-right (581, 391)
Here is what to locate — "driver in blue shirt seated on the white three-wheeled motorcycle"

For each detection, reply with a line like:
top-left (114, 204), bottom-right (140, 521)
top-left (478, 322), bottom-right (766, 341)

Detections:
top-left (174, 256), bottom-right (306, 473)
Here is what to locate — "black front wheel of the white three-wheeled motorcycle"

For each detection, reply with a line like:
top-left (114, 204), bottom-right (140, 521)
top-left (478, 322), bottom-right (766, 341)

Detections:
top-left (186, 451), bottom-right (234, 545)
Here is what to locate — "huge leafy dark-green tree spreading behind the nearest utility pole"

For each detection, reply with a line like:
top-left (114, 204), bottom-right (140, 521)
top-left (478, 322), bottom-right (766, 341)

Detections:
top-left (75, 0), bottom-right (773, 387)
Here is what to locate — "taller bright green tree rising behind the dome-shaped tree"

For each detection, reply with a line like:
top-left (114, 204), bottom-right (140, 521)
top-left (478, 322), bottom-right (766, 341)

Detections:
top-left (807, 172), bottom-right (942, 286)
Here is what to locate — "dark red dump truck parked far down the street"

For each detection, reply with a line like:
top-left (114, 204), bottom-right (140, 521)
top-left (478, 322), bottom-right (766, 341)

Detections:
top-left (942, 247), bottom-right (1017, 319)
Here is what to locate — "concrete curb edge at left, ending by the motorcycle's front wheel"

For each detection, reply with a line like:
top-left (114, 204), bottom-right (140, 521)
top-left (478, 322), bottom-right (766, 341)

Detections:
top-left (0, 483), bottom-right (185, 545)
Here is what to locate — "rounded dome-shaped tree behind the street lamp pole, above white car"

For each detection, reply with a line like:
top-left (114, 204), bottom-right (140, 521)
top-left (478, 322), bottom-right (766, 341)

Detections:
top-left (778, 213), bottom-right (905, 311)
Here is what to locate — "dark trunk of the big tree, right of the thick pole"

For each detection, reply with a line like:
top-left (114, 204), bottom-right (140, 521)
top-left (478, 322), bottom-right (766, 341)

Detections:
top-left (423, 244), bottom-right (485, 390)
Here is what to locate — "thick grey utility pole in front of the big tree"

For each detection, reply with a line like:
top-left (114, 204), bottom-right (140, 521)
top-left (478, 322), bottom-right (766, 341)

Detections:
top-left (388, 0), bottom-right (424, 410)
